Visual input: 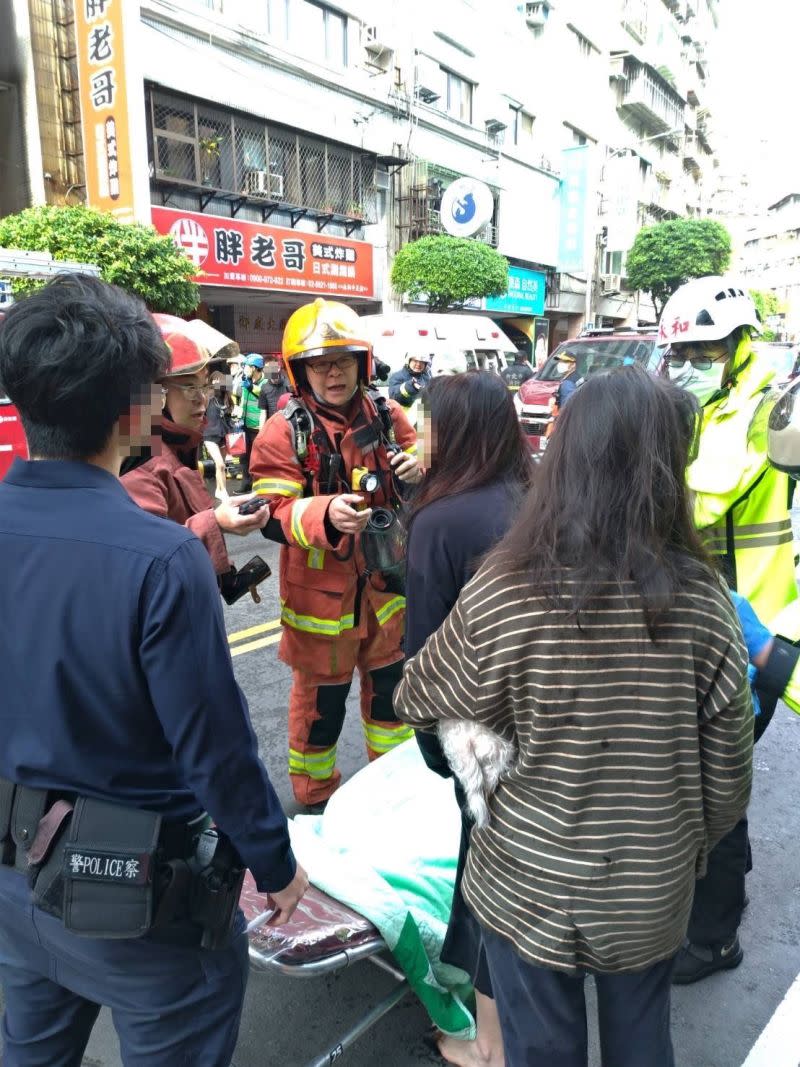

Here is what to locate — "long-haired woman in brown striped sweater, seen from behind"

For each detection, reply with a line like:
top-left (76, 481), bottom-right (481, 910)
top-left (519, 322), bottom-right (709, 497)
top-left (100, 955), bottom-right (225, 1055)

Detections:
top-left (395, 367), bottom-right (753, 1067)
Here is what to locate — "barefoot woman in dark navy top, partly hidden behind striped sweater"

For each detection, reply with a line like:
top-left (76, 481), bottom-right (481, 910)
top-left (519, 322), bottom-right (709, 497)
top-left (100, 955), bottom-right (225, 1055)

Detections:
top-left (404, 370), bottom-right (533, 1067)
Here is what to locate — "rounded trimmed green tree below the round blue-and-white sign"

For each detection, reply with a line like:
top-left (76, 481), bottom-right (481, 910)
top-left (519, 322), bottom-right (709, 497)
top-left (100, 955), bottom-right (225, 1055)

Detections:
top-left (391, 234), bottom-right (509, 312)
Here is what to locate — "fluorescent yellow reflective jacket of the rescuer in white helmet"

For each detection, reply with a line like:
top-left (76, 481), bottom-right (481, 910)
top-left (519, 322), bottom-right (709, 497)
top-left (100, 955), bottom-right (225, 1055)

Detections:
top-left (687, 339), bottom-right (797, 619)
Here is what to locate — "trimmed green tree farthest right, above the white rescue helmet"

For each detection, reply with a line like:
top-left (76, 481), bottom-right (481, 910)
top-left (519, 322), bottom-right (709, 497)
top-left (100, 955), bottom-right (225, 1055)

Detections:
top-left (625, 219), bottom-right (731, 318)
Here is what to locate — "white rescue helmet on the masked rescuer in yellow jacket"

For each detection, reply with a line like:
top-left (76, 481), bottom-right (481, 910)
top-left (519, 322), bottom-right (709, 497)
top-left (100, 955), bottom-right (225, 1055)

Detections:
top-left (658, 274), bottom-right (761, 346)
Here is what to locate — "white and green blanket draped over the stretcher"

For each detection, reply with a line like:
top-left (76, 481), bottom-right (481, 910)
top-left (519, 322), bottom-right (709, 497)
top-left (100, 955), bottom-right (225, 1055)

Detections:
top-left (290, 740), bottom-right (475, 1038)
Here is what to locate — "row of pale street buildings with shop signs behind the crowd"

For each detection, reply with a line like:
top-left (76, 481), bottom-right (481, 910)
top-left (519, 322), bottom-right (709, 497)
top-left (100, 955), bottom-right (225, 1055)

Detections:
top-left (0, 0), bottom-right (716, 353)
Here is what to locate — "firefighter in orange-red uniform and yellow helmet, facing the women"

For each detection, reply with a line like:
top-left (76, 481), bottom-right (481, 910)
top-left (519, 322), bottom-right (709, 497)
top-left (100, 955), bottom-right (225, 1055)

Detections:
top-left (251, 299), bottom-right (421, 810)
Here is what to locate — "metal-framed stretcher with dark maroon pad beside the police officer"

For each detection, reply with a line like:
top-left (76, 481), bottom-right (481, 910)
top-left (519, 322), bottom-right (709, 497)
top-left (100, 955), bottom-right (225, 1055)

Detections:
top-left (240, 872), bottom-right (411, 1067)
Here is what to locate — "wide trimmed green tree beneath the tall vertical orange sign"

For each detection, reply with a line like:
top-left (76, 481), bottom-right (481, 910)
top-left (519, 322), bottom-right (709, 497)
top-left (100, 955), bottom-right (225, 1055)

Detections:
top-left (0, 206), bottom-right (199, 315)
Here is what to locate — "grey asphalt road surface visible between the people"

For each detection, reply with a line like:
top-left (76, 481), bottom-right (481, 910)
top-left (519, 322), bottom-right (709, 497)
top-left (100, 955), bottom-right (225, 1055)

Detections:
top-left (1, 535), bottom-right (800, 1067)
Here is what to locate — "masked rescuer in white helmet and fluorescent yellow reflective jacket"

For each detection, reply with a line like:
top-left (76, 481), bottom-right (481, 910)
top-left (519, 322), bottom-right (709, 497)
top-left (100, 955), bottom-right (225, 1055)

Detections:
top-left (658, 276), bottom-right (797, 985)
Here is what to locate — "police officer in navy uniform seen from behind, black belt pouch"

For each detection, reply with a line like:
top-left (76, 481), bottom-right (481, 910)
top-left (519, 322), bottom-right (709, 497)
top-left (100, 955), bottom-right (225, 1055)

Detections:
top-left (0, 275), bottom-right (307, 1067)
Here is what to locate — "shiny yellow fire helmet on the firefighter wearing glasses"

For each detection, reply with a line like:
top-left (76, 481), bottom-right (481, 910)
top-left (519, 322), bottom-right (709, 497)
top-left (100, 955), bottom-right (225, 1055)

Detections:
top-left (282, 297), bottom-right (372, 393)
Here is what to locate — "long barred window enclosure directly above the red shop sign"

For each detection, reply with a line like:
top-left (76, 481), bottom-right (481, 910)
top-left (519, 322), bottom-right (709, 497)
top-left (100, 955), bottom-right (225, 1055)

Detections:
top-left (147, 90), bottom-right (378, 223)
